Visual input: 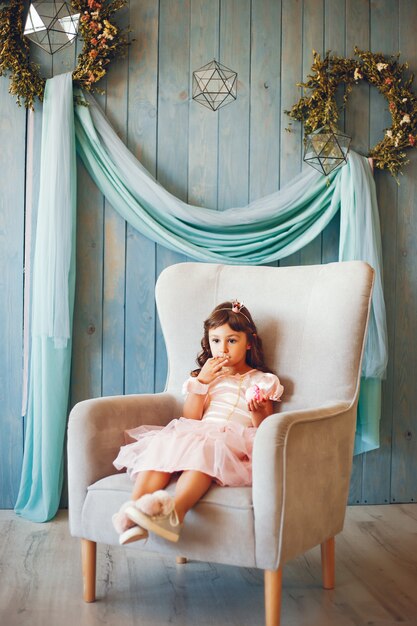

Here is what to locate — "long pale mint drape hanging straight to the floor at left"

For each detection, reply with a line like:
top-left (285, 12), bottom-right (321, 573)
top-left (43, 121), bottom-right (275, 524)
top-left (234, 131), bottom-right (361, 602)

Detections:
top-left (15, 74), bottom-right (76, 522)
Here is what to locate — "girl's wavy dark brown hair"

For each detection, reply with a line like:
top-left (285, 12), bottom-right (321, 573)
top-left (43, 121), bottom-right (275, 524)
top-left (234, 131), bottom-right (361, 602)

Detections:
top-left (191, 302), bottom-right (272, 377)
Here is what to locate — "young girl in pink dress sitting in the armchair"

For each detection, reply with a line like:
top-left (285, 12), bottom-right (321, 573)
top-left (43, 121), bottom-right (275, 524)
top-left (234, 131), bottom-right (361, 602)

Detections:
top-left (112, 301), bottom-right (283, 544)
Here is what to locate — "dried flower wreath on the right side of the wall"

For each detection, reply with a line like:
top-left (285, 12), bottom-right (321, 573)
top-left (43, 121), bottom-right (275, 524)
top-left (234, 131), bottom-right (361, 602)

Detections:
top-left (285, 47), bottom-right (417, 178)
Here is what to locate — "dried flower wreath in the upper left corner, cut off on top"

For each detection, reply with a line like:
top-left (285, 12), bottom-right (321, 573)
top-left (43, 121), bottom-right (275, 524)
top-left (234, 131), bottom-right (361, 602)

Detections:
top-left (0, 0), bottom-right (128, 109)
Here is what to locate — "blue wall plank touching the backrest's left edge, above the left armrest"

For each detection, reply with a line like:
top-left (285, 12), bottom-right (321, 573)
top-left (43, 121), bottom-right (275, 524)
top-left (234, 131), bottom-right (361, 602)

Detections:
top-left (124, 0), bottom-right (159, 393)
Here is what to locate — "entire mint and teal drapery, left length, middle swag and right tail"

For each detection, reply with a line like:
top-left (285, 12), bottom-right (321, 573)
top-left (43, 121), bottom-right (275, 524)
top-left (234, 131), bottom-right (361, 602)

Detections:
top-left (16, 75), bottom-right (387, 521)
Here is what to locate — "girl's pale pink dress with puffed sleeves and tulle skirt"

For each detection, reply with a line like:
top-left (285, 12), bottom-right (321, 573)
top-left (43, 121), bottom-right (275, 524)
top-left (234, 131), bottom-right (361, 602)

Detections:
top-left (114, 369), bottom-right (284, 487)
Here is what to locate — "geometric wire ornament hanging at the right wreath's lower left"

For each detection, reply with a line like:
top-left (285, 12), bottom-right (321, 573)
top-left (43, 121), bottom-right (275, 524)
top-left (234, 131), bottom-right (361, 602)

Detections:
top-left (304, 126), bottom-right (351, 176)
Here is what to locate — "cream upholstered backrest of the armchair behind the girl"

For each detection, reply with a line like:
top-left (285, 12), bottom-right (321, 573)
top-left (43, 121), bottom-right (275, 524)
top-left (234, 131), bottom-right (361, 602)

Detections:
top-left (156, 261), bottom-right (373, 410)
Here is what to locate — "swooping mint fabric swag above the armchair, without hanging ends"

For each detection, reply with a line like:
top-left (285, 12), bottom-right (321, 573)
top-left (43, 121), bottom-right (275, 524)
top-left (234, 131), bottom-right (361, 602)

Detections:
top-left (75, 98), bottom-right (341, 265)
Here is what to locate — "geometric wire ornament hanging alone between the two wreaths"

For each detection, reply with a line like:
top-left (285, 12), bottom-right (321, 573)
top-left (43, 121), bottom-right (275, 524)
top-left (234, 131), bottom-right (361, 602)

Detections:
top-left (193, 60), bottom-right (237, 111)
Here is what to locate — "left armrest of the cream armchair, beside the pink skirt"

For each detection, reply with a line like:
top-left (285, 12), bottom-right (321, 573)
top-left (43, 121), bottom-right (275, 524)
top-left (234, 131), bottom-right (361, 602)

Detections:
top-left (68, 393), bottom-right (181, 534)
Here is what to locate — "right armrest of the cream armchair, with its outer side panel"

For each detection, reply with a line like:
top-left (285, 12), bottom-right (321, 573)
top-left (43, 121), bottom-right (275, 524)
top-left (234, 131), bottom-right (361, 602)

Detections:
top-left (253, 401), bottom-right (357, 569)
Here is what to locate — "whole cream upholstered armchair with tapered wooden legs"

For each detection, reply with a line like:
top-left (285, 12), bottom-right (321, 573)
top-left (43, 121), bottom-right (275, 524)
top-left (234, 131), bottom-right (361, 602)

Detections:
top-left (68, 262), bottom-right (373, 626)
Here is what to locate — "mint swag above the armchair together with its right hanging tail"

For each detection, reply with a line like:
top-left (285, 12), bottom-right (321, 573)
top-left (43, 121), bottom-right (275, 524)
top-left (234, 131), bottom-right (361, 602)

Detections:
top-left (75, 92), bottom-right (387, 378)
